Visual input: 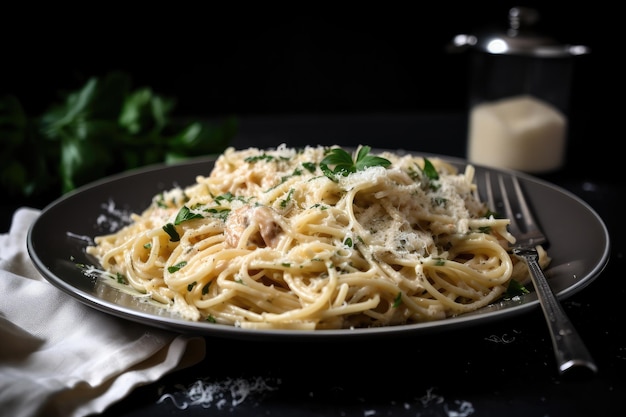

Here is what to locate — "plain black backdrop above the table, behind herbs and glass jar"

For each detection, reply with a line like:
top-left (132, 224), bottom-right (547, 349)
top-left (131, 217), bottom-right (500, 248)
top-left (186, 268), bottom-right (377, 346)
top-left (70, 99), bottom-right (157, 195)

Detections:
top-left (0, 1), bottom-right (608, 169)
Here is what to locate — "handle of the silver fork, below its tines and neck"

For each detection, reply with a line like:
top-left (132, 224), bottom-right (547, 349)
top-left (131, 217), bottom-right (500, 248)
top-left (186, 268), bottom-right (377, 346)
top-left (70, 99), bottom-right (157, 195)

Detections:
top-left (513, 249), bottom-right (598, 374)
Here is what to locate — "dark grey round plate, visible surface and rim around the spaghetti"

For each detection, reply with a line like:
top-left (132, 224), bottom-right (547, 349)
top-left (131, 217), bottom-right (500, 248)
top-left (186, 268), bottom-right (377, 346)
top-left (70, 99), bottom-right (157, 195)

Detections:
top-left (27, 154), bottom-right (609, 340)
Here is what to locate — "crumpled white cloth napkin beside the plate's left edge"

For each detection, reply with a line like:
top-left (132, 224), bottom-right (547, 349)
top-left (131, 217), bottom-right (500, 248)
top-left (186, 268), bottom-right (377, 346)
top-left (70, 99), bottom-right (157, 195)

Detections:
top-left (0, 207), bottom-right (205, 417)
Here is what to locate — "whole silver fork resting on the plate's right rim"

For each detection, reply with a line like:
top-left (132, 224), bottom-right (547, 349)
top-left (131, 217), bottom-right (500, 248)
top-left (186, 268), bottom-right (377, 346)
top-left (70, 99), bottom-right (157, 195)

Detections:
top-left (484, 171), bottom-right (598, 374)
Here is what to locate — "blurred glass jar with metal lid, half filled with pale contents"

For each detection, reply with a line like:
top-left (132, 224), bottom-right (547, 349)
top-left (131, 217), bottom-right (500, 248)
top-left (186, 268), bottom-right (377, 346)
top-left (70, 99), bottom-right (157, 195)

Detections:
top-left (453, 7), bottom-right (590, 174)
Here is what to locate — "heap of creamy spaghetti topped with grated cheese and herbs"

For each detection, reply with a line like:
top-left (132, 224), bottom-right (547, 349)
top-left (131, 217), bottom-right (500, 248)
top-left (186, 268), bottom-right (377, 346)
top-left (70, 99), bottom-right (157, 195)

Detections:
top-left (87, 145), bottom-right (549, 330)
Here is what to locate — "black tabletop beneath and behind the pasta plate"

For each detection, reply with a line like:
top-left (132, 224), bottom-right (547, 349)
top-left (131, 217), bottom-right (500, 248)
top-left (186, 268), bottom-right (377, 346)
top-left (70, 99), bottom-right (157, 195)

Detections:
top-left (2, 114), bottom-right (626, 417)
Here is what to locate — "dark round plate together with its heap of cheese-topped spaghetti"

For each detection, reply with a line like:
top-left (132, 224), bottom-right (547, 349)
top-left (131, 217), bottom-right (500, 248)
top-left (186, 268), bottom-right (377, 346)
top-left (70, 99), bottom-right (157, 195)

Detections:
top-left (27, 144), bottom-right (609, 339)
